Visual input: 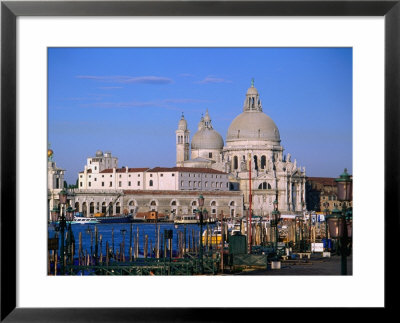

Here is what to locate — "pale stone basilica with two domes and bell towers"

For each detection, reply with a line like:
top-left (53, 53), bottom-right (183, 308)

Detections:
top-left (176, 81), bottom-right (306, 215)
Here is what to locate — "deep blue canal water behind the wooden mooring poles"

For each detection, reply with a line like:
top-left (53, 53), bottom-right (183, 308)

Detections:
top-left (48, 223), bottom-right (219, 259)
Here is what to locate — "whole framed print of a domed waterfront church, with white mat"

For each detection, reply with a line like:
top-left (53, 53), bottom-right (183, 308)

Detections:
top-left (1, 0), bottom-right (400, 322)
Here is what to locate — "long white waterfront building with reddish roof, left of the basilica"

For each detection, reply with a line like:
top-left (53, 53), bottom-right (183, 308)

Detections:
top-left (69, 150), bottom-right (243, 219)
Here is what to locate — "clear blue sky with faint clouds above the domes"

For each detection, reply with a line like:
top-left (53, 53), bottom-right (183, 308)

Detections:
top-left (48, 48), bottom-right (352, 184)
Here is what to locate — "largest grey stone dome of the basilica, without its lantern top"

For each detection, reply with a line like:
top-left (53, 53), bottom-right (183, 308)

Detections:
top-left (226, 111), bottom-right (281, 142)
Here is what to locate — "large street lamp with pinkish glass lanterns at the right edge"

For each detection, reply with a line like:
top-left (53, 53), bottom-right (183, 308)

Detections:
top-left (328, 168), bottom-right (353, 275)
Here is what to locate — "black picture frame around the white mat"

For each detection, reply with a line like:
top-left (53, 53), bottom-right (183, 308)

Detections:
top-left (0, 0), bottom-right (400, 322)
